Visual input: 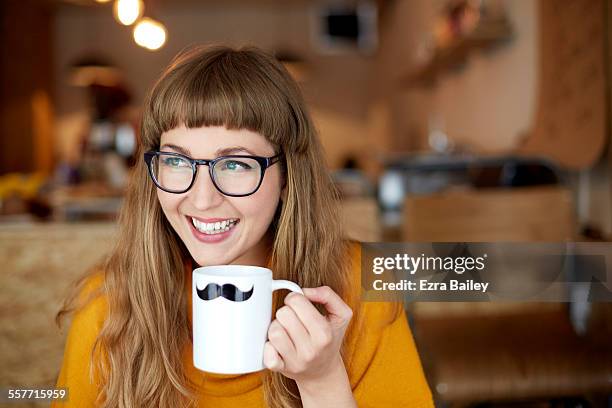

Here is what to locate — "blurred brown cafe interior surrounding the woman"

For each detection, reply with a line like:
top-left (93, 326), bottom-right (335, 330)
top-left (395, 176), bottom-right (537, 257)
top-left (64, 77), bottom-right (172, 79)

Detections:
top-left (0, 0), bottom-right (612, 407)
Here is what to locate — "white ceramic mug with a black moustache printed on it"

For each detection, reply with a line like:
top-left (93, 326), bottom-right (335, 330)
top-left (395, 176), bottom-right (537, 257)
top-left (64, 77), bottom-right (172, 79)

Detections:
top-left (192, 265), bottom-right (302, 374)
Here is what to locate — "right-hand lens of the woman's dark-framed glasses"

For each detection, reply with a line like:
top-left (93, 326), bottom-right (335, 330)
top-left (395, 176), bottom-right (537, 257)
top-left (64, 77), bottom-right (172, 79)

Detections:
top-left (213, 157), bottom-right (261, 195)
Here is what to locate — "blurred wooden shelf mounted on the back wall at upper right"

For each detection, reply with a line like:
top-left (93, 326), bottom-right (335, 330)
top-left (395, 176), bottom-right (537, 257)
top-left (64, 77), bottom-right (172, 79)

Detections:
top-left (401, 19), bottom-right (513, 87)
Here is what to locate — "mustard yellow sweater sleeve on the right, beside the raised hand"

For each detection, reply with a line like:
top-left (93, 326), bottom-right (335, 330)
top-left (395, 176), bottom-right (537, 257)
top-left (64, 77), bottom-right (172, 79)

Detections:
top-left (347, 242), bottom-right (433, 408)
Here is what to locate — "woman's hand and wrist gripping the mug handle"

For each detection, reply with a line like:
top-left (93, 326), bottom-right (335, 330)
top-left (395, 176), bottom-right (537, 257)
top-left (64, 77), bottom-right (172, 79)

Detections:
top-left (264, 286), bottom-right (354, 406)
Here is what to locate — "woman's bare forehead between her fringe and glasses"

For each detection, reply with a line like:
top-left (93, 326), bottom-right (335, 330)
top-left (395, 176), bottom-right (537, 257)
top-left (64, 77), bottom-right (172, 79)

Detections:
top-left (160, 126), bottom-right (274, 158)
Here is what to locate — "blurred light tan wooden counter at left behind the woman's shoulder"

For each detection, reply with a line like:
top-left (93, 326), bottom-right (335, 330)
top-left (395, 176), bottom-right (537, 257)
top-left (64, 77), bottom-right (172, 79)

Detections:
top-left (0, 223), bottom-right (116, 396)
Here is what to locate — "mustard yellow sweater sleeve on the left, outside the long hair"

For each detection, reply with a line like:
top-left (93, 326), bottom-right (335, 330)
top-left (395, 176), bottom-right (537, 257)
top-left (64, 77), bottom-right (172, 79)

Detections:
top-left (51, 276), bottom-right (107, 408)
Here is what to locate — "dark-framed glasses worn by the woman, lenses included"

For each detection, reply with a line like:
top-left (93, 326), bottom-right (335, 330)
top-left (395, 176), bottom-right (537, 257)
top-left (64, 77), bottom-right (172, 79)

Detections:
top-left (144, 150), bottom-right (282, 197)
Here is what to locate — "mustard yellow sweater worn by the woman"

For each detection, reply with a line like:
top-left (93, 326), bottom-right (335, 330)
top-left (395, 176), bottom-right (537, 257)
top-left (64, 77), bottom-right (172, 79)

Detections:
top-left (51, 245), bottom-right (433, 408)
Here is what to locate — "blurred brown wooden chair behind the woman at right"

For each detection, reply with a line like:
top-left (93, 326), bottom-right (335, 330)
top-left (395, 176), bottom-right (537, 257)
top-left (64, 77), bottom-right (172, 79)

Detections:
top-left (403, 187), bottom-right (612, 405)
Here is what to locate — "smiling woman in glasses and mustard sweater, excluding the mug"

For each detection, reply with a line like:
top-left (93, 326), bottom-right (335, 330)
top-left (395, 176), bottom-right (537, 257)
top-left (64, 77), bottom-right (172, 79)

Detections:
top-left (57, 47), bottom-right (432, 407)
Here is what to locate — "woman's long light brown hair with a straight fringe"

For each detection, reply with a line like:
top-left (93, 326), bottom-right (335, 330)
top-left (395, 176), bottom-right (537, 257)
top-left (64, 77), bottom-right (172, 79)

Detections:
top-left (56, 46), bottom-right (355, 408)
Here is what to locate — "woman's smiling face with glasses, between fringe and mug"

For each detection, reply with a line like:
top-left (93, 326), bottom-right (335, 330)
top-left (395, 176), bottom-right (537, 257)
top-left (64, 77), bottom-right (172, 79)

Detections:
top-left (149, 126), bottom-right (281, 260)
